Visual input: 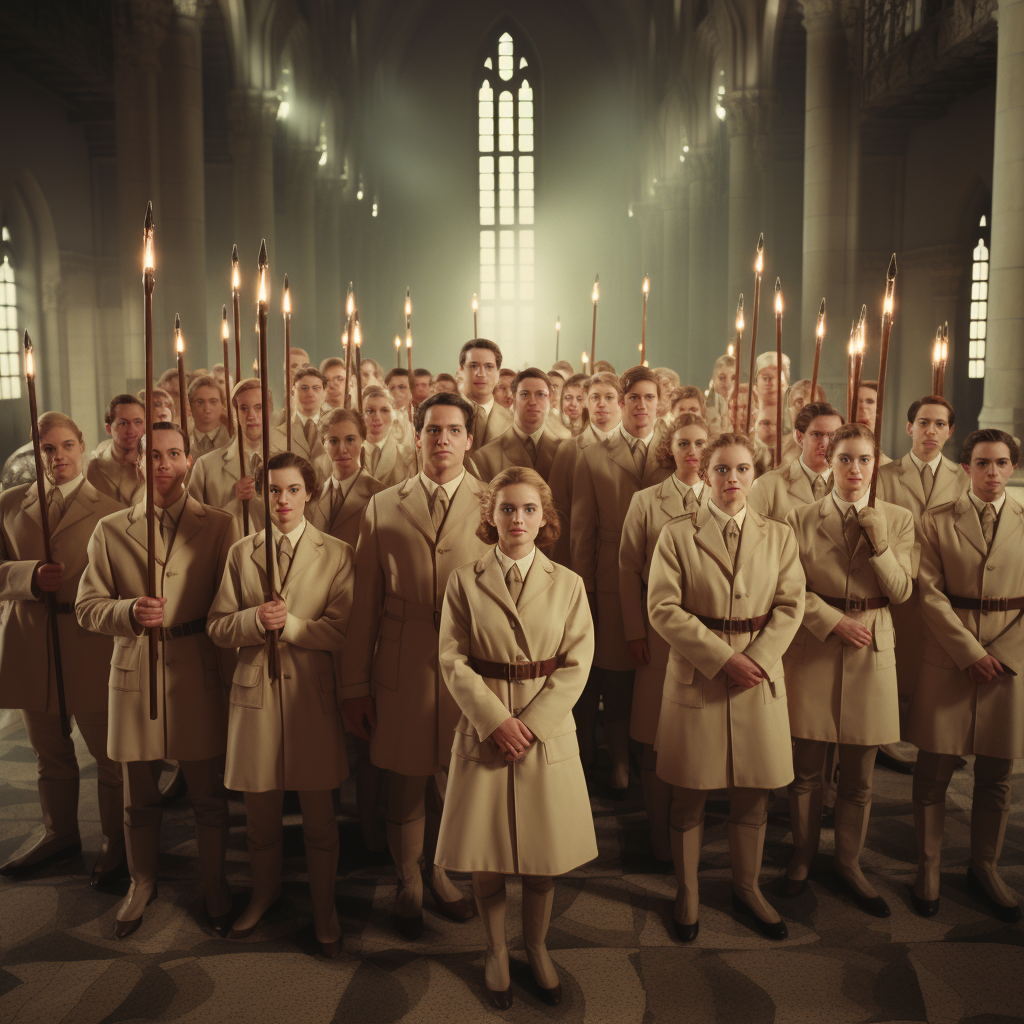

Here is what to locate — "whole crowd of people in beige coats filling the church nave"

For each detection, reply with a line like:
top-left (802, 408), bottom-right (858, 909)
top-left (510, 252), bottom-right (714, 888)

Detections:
top-left (0, 339), bottom-right (1024, 1009)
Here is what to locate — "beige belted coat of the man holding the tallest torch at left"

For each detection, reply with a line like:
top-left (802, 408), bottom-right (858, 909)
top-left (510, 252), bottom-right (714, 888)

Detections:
top-left (76, 498), bottom-right (239, 761)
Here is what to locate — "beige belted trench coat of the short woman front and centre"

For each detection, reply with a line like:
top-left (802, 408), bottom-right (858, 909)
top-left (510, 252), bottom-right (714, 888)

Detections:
top-left (435, 549), bottom-right (597, 874)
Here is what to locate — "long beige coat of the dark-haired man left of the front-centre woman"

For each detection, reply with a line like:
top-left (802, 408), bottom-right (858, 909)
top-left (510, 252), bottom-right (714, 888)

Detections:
top-left (341, 473), bottom-right (489, 775)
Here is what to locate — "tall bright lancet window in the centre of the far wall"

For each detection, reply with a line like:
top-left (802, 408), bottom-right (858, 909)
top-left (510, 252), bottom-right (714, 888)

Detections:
top-left (477, 32), bottom-right (538, 353)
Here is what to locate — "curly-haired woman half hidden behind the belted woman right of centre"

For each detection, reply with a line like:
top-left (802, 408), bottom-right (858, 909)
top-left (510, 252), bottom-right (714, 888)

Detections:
top-left (618, 413), bottom-right (709, 860)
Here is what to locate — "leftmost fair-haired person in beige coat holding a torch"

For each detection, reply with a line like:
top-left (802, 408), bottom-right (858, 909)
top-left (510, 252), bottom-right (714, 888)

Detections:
top-left (0, 413), bottom-right (125, 887)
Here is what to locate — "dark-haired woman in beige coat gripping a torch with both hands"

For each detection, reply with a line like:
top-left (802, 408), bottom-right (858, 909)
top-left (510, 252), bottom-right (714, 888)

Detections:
top-left (208, 452), bottom-right (355, 958)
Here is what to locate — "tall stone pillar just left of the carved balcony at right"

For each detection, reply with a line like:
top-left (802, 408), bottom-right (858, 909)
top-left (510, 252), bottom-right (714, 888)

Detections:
top-left (792, 0), bottom-right (856, 394)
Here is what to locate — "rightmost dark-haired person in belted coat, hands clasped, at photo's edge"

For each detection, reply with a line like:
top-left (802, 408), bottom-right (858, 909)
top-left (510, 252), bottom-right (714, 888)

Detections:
top-left (907, 429), bottom-right (1024, 924)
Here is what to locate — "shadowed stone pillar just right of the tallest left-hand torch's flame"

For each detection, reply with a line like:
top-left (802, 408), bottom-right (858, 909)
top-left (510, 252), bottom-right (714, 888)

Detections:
top-left (155, 0), bottom-right (207, 371)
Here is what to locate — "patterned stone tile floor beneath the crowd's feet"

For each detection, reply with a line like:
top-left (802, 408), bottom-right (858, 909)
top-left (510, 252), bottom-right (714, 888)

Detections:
top-left (0, 724), bottom-right (1024, 1024)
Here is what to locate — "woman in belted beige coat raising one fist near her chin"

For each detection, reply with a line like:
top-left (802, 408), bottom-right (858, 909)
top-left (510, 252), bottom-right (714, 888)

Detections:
top-left (778, 419), bottom-right (913, 918)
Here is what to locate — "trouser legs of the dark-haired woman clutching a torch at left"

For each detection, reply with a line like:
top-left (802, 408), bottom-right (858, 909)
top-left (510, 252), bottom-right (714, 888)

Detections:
top-left (245, 790), bottom-right (341, 942)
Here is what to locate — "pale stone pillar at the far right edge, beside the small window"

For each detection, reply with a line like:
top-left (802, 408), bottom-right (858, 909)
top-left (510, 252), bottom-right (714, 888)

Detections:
top-left (979, 0), bottom-right (1024, 437)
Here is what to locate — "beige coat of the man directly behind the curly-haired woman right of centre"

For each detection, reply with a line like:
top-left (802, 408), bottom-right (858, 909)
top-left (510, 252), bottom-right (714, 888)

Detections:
top-left (569, 427), bottom-right (671, 672)
